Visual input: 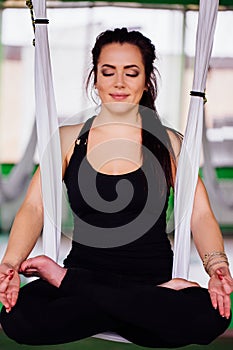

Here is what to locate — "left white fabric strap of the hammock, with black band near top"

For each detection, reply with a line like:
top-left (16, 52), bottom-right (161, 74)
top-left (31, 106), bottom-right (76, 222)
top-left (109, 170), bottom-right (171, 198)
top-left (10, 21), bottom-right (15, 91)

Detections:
top-left (33, 0), bottom-right (62, 261)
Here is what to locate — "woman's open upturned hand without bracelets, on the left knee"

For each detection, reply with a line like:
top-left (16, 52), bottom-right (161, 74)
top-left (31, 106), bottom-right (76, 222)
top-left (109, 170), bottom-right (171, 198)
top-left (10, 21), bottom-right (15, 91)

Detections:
top-left (0, 263), bottom-right (20, 312)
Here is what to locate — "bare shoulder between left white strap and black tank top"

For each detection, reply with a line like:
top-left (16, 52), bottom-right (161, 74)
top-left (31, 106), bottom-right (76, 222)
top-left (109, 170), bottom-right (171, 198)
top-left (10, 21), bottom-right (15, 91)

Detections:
top-left (59, 123), bottom-right (83, 171)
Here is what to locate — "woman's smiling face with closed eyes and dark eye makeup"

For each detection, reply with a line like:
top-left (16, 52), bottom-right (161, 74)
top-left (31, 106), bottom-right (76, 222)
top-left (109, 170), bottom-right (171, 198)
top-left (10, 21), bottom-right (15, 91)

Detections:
top-left (95, 43), bottom-right (146, 112)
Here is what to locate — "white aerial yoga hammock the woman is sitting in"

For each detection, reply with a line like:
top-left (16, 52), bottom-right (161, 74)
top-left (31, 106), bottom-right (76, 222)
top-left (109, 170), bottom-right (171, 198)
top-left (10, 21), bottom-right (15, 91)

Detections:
top-left (33, 0), bottom-right (218, 341)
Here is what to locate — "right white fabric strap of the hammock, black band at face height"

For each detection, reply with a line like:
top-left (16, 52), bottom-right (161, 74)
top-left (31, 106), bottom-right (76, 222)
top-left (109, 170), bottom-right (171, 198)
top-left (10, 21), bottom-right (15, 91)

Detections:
top-left (173, 0), bottom-right (219, 278)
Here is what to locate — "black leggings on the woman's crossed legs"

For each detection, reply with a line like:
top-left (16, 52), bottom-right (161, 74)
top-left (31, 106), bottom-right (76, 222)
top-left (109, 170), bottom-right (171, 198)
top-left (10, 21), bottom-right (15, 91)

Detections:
top-left (0, 268), bottom-right (230, 348)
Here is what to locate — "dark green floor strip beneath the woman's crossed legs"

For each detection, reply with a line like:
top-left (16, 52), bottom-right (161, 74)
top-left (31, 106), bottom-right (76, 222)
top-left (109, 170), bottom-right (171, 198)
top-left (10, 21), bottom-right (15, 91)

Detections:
top-left (0, 331), bottom-right (233, 350)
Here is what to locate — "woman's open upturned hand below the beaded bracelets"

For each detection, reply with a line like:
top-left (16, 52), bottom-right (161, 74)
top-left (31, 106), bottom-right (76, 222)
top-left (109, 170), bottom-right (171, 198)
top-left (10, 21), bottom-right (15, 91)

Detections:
top-left (208, 266), bottom-right (233, 319)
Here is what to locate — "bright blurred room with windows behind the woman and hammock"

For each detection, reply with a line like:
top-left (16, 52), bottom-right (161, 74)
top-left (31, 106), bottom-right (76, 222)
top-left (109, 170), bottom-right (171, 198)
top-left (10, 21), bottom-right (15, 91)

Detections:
top-left (0, 0), bottom-right (233, 345)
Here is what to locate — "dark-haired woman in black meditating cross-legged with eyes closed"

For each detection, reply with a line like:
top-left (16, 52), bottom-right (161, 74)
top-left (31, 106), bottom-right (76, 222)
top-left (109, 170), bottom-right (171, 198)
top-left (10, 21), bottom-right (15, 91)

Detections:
top-left (0, 28), bottom-right (233, 347)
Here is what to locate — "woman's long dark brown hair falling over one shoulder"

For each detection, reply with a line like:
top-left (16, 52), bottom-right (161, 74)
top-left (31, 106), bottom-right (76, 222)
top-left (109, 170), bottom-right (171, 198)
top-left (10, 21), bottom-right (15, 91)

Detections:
top-left (86, 28), bottom-right (177, 189)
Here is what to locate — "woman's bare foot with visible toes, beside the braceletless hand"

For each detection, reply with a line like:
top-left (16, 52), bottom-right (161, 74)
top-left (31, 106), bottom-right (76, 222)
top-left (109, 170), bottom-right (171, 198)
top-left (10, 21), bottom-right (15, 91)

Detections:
top-left (19, 255), bottom-right (67, 287)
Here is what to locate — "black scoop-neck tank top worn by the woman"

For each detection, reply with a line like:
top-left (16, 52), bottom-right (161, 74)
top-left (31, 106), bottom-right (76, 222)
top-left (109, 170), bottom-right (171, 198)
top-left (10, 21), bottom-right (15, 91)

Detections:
top-left (64, 117), bottom-right (173, 284)
